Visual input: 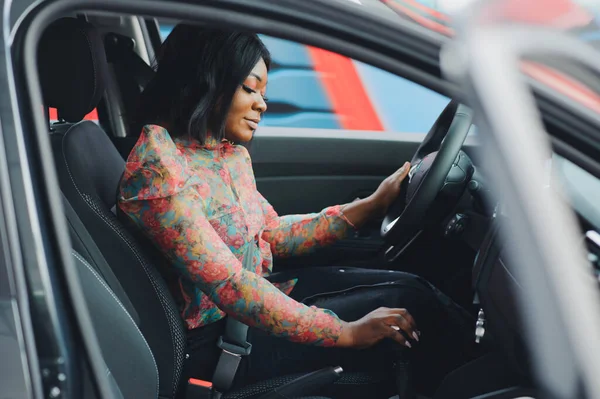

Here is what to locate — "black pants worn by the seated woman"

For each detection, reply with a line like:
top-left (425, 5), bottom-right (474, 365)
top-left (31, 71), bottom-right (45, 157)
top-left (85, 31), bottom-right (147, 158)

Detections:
top-left (187, 267), bottom-right (474, 398)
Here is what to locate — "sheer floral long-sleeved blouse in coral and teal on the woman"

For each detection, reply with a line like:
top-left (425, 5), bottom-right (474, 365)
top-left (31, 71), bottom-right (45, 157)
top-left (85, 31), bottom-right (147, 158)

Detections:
top-left (119, 125), bottom-right (352, 346)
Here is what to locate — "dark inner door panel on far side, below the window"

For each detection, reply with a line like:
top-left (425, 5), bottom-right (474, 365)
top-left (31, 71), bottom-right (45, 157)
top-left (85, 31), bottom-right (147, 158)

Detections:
top-left (248, 127), bottom-right (476, 267)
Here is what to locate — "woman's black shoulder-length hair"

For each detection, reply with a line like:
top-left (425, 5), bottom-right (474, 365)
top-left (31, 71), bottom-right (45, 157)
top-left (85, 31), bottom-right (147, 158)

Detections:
top-left (136, 24), bottom-right (271, 144)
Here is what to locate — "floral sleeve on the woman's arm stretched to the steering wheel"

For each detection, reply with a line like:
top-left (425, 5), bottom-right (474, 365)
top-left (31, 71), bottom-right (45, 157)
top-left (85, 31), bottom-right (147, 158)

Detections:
top-left (259, 194), bottom-right (353, 257)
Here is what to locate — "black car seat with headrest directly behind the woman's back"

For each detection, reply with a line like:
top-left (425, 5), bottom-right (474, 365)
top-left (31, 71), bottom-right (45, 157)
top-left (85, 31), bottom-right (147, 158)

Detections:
top-left (38, 18), bottom-right (384, 399)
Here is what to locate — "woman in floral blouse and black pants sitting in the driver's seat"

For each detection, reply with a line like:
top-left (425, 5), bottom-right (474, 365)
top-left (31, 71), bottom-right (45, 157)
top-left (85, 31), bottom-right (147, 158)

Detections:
top-left (119, 25), bottom-right (472, 397)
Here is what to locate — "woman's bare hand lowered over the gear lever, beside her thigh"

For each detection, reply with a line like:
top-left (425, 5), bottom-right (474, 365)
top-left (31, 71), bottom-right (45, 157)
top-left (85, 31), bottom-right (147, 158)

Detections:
top-left (336, 308), bottom-right (420, 348)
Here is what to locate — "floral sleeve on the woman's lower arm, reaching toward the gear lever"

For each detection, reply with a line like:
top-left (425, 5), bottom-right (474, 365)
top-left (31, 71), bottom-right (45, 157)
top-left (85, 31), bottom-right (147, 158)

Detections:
top-left (119, 126), bottom-right (342, 346)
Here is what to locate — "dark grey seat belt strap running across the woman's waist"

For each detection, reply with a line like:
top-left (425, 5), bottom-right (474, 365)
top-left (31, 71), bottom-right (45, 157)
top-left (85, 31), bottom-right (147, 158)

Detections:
top-left (212, 243), bottom-right (253, 399)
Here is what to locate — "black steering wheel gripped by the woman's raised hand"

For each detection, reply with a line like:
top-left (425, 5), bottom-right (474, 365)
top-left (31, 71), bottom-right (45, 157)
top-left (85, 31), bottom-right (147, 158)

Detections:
top-left (381, 101), bottom-right (473, 261)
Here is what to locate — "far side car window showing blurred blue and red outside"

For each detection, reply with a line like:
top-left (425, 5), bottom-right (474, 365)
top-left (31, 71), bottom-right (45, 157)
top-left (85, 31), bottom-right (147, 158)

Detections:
top-left (159, 22), bottom-right (450, 133)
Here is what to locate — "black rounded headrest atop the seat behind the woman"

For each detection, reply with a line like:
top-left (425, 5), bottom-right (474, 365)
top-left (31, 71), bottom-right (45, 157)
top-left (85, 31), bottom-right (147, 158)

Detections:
top-left (38, 18), bottom-right (108, 122)
